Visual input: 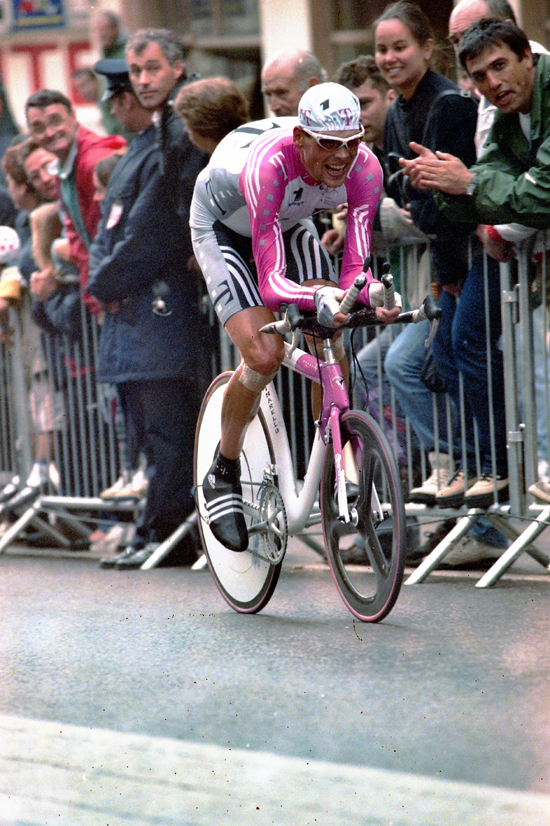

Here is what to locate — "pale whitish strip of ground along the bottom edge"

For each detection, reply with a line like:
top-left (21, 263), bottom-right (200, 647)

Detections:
top-left (0, 715), bottom-right (550, 826)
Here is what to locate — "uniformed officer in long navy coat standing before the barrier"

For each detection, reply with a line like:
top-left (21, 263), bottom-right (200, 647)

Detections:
top-left (89, 61), bottom-right (211, 570)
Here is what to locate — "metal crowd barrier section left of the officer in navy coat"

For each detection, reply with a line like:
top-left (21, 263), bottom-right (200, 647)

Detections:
top-left (0, 294), bottom-right (139, 553)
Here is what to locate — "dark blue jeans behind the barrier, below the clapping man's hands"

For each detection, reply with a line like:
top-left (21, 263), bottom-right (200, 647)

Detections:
top-left (434, 257), bottom-right (508, 477)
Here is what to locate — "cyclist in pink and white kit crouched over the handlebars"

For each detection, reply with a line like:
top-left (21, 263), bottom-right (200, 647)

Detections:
top-left (190, 83), bottom-right (400, 551)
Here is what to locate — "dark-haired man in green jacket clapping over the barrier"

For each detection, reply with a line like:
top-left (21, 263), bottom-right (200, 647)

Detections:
top-left (400, 20), bottom-right (550, 229)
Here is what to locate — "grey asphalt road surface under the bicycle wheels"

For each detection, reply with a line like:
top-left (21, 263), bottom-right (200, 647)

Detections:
top-left (0, 549), bottom-right (550, 793)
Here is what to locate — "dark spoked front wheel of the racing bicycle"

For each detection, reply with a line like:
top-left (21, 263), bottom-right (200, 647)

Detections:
top-left (320, 410), bottom-right (406, 622)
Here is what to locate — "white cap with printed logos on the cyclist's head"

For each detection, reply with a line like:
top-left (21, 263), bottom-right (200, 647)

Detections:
top-left (298, 83), bottom-right (361, 132)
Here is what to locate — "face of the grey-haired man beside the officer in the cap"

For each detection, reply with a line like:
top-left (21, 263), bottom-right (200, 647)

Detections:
top-left (127, 43), bottom-right (183, 110)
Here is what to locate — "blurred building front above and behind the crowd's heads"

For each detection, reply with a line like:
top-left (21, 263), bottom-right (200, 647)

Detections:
top-left (0, 0), bottom-right (549, 126)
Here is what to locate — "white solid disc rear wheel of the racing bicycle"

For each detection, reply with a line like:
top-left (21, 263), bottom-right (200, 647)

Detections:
top-left (193, 372), bottom-right (282, 614)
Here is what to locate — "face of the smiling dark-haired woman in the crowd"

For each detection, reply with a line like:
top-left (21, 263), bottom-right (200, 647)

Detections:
top-left (375, 19), bottom-right (433, 100)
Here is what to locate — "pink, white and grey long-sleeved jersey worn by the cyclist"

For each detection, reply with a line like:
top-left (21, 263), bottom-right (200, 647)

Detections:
top-left (190, 118), bottom-right (382, 311)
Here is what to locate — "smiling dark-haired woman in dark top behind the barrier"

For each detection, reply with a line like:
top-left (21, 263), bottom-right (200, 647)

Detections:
top-left (375, 0), bottom-right (477, 289)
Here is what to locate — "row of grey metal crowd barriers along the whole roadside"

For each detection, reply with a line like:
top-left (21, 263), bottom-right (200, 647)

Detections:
top-left (0, 240), bottom-right (550, 587)
